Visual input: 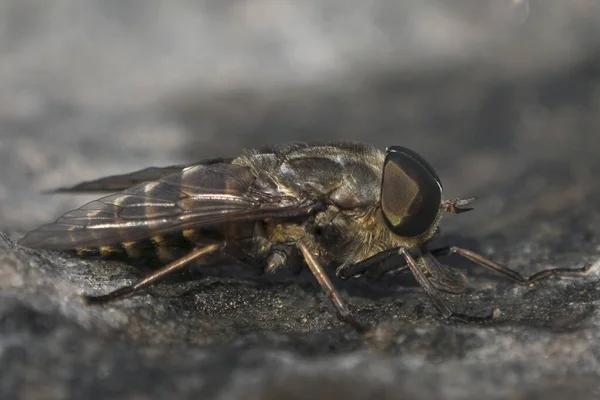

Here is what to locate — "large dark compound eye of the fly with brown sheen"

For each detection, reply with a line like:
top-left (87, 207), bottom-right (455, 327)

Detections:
top-left (381, 146), bottom-right (442, 237)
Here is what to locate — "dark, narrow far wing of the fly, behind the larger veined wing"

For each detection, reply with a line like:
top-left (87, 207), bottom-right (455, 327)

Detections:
top-left (48, 158), bottom-right (232, 193)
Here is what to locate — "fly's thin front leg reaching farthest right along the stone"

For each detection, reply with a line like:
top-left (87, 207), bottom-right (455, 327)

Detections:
top-left (431, 246), bottom-right (590, 285)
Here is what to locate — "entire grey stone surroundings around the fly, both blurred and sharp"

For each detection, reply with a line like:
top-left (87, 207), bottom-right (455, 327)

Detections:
top-left (0, 0), bottom-right (600, 399)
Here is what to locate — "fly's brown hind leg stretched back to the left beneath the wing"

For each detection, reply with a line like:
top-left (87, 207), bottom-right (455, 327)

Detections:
top-left (82, 244), bottom-right (222, 305)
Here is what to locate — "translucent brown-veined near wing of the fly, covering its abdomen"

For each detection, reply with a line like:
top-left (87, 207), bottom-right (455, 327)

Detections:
top-left (19, 163), bottom-right (315, 250)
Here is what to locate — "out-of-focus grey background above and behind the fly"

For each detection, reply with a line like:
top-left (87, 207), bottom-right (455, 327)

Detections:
top-left (0, 0), bottom-right (600, 245)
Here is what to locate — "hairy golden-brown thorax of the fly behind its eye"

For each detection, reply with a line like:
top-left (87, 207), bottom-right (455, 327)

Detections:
top-left (233, 144), bottom-right (437, 267)
